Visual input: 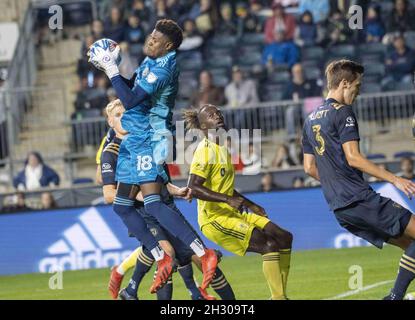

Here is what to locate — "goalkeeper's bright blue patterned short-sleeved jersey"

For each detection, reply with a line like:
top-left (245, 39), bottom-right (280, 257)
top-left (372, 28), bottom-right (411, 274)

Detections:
top-left (122, 51), bottom-right (179, 134)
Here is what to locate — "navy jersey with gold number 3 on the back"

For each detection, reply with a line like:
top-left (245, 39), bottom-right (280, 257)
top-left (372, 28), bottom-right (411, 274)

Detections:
top-left (303, 99), bottom-right (373, 211)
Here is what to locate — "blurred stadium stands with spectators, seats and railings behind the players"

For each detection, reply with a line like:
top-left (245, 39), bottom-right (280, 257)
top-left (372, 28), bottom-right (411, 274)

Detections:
top-left (0, 0), bottom-right (415, 213)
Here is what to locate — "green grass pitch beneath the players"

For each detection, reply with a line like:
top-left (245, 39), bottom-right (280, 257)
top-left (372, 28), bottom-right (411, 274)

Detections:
top-left (0, 246), bottom-right (415, 300)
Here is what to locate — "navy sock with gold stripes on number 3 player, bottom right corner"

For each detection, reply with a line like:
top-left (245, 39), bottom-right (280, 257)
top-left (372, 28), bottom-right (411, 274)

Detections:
top-left (391, 241), bottom-right (415, 300)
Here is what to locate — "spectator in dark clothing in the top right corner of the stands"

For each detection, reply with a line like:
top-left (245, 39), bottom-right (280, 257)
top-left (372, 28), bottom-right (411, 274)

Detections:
top-left (386, 0), bottom-right (415, 32)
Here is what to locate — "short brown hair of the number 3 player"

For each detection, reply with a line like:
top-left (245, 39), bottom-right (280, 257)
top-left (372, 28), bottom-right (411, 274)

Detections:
top-left (326, 59), bottom-right (365, 90)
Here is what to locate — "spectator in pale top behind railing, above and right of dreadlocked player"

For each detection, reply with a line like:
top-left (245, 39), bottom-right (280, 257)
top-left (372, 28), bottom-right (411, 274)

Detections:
top-left (225, 66), bottom-right (259, 108)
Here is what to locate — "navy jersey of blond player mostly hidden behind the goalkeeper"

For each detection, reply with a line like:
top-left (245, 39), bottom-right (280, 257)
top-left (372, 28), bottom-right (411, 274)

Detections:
top-left (101, 137), bottom-right (174, 204)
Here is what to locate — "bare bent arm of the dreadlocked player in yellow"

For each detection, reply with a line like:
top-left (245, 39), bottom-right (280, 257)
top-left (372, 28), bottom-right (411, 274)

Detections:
top-left (188, 174), bottom-right (245, 210)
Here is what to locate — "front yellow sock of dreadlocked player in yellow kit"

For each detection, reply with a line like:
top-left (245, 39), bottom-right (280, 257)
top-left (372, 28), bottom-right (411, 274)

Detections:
top-left (262, 252), bottom-right (285, 300)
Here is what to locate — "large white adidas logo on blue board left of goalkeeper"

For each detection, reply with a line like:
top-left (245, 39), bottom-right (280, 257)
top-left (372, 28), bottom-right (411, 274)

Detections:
top-left (39, 208), bottom-right (131, 272)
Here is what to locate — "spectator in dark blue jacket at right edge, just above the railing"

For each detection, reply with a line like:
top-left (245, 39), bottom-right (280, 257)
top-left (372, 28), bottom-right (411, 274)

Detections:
top-left (382, 35), bottom-right (415, 90)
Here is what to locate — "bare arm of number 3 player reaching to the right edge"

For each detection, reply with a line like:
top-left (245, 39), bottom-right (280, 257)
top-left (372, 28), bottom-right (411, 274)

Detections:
top-left (342, 141), bottom-right (415, 199)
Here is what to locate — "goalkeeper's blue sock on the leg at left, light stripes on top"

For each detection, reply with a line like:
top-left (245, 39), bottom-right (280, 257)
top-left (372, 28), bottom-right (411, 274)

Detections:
top-left (114, 196), bottom-right (158, 254)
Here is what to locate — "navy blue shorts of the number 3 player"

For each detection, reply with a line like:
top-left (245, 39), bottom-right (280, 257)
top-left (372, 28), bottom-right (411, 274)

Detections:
top-left (334, 192), bottom-right (412, 249)
